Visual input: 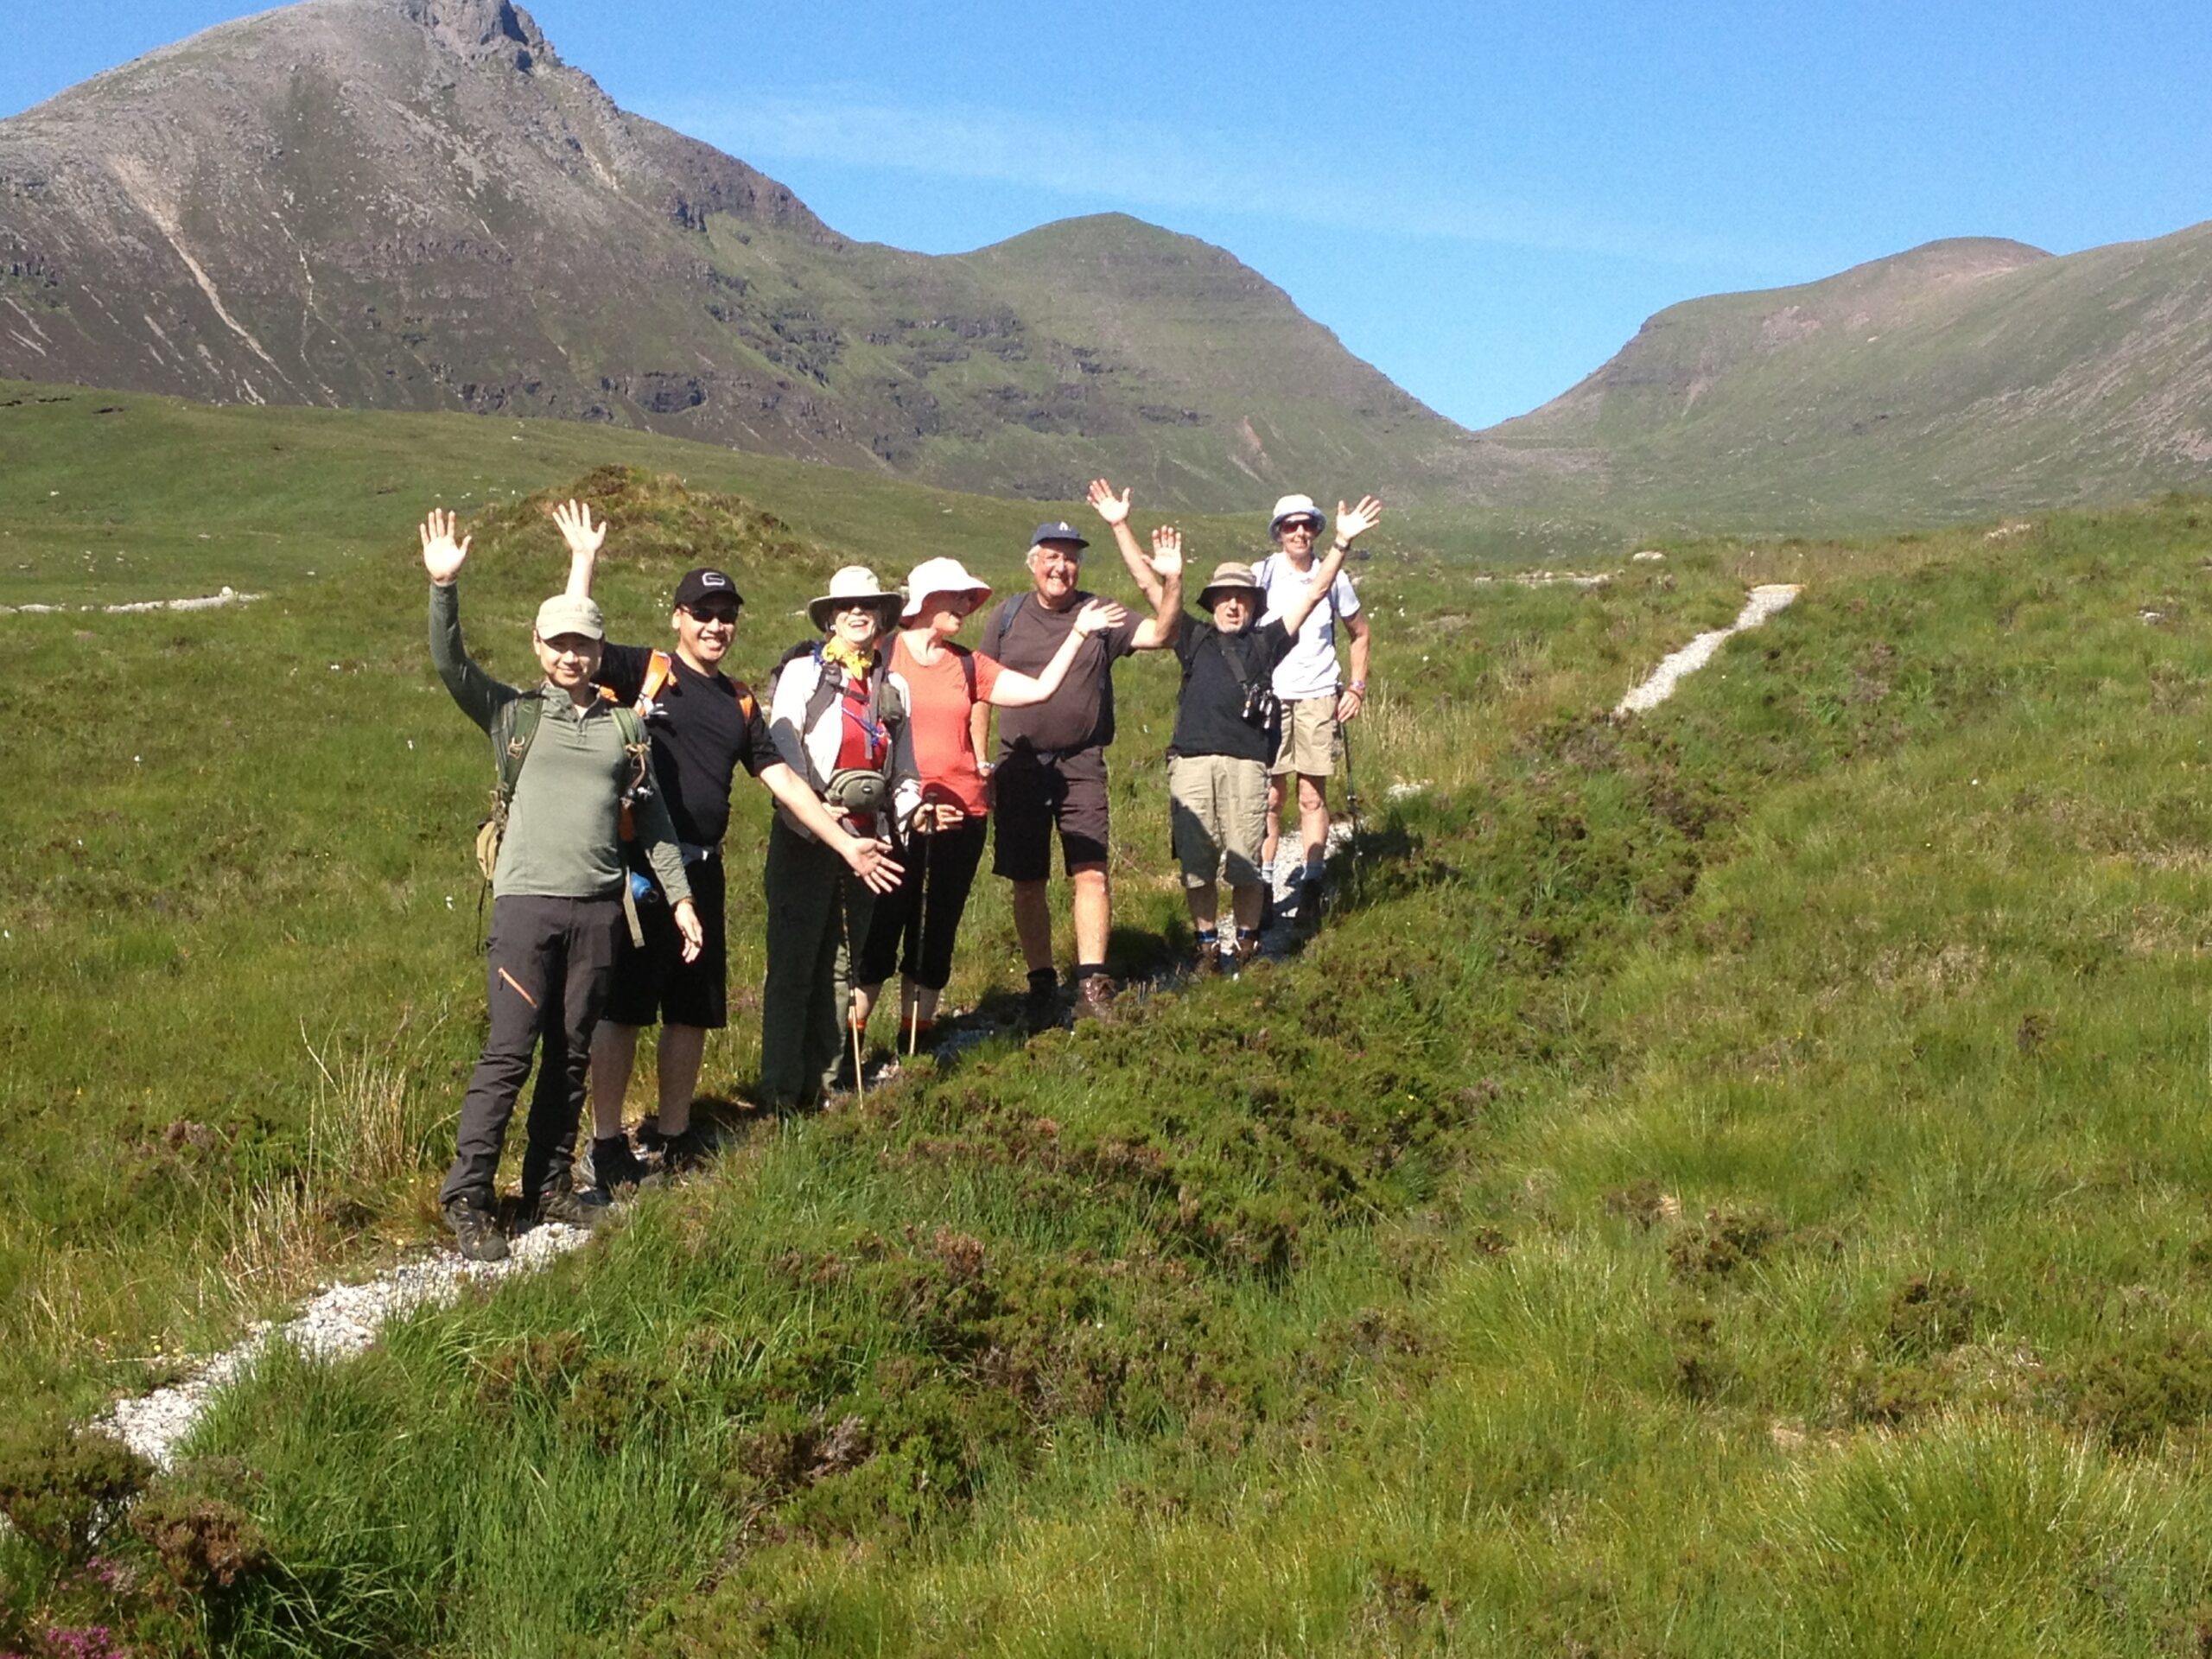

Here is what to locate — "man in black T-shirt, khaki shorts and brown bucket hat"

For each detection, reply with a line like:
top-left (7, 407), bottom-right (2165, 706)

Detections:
top-left (1168, 495), bottom-right (1382, 973)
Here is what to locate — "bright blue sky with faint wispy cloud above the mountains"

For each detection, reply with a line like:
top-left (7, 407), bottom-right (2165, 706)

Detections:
top-left (0, 0), bottom-right (2212, 427)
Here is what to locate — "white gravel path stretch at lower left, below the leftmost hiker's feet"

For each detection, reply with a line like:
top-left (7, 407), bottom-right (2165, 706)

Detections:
top-left (99, 1225), bottom-right (591, 1469)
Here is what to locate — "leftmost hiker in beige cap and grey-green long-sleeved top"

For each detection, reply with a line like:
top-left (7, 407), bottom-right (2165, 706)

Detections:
top-left (423, 511), bottom-right (702, 1261)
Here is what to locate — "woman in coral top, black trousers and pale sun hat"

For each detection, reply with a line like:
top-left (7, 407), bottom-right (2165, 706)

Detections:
top-left (852, 560), bottom-right (1128, 1046)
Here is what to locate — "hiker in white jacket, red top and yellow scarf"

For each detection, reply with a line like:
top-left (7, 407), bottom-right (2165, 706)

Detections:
top-left (761, 564), bottom-right (923, 1109)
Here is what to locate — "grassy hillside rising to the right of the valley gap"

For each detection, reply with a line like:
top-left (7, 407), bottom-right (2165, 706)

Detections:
top-left (1482, 226), bottom-right (2212, 529)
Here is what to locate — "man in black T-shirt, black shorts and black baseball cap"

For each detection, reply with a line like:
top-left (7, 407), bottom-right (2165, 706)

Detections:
top-left (553, 502), bottom-right (900, 1192)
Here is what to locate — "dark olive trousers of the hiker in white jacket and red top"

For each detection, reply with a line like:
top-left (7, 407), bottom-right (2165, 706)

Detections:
top-left (761, 812), bottom-right (876, 1106)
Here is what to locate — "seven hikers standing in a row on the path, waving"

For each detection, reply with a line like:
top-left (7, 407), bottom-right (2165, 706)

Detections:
top-left (420, 478), bottom-right (1382, 1261)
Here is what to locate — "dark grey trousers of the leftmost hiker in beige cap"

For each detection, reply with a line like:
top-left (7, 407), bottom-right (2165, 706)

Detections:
top-left (438, 893), bottom-right (624, 1208)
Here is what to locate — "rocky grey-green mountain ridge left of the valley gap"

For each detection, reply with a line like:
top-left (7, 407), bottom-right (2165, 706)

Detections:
top-left (0, 0), bottom-right (1466, 506)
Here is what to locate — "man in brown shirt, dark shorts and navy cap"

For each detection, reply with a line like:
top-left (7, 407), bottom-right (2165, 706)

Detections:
top-left (978, 520), bottom-right (1184, 1031)
